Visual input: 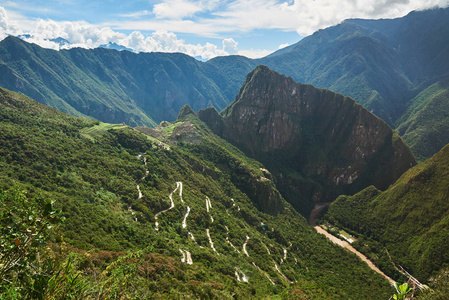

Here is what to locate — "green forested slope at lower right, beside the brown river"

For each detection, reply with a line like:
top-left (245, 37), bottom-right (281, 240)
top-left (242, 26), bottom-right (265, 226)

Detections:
top-left (326, 142), bottom-right (449, 282)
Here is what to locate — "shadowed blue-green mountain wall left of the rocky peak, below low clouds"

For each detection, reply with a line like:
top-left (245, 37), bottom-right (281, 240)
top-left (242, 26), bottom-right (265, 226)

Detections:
top-left (0, 37), bottom-right (228, 126)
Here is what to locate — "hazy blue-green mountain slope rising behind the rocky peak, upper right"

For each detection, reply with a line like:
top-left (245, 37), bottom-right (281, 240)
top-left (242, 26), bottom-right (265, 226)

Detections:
top-left (261, 8), bottom-right (449, 125)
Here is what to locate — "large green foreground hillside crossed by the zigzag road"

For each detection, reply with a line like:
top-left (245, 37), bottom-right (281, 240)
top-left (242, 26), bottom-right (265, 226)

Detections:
top-left (0, 89), bottom-right (393, 299)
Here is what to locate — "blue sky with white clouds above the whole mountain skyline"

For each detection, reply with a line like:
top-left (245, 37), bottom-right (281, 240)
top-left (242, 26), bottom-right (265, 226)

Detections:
top-left (0, 0), bottom-right (449, 60)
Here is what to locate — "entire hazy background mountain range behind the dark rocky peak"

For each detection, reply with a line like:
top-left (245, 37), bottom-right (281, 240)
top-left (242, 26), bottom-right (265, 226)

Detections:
top-left (0, 8), bottom-right (449, 160)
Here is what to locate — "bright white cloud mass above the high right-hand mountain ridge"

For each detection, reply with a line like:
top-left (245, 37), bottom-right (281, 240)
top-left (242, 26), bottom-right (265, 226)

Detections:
top-left (205, 0), bottom-right (449, 36)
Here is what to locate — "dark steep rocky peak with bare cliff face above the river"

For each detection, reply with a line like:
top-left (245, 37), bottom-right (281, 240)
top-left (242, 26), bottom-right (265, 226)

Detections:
top-left (201, 66), bottom-right (416, 215)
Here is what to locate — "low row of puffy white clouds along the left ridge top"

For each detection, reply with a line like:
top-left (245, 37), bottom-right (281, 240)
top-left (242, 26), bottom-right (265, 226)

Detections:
top-left (0, 7), bottom-right (234, 59)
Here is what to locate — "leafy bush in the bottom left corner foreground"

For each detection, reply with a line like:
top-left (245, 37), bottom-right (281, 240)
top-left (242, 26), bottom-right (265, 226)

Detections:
top-left (0, 186), bottom-right (64, 292)
